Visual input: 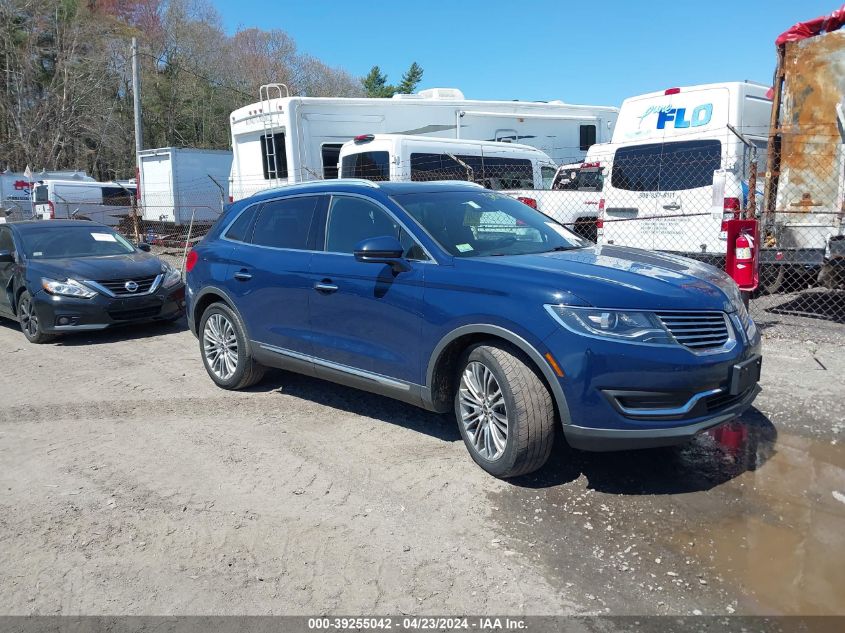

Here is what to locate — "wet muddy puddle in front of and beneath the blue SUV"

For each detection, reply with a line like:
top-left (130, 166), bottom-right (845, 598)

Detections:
top-left (490, 411), bottom-right (845, 615)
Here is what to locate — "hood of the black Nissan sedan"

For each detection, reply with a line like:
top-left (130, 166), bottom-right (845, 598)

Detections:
top-left (27, 252), bottom-right (161, 281)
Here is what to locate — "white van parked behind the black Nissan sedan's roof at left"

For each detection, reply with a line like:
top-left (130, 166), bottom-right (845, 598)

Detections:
top-left (32, 179), bottom-right (135, 226)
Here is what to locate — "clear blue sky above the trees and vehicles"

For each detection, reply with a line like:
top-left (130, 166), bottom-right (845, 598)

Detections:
top-left (212, 0), bottom-right (841, 105)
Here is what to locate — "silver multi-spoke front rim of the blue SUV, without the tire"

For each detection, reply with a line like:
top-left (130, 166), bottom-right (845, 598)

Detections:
top-left (459, 361), bottom-right (508, 462)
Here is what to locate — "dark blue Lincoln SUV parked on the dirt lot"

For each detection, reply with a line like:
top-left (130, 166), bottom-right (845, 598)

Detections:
top-left (186, 180), bottom-right (761, 477)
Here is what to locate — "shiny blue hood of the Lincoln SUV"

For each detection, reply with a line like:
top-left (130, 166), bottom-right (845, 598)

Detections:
top-left (462, 246), bottom-right (741, 312)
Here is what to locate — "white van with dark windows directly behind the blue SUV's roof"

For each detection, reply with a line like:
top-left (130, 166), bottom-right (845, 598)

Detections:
top-left (338, 134), bottom-right (557, 190)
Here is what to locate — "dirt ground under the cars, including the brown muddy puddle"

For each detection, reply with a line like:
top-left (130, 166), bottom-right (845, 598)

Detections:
top-left (0, 312), bottom-right (845, 615)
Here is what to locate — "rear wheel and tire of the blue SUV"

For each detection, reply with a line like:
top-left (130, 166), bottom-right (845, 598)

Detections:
top-left (198, 303), bottom-right (265, 390)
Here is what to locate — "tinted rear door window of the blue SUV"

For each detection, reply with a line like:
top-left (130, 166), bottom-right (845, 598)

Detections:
top-left (252, 196), bottom-right (320, 250)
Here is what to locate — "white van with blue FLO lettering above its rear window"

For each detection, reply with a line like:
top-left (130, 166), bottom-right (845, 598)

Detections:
top-left (598, 82), bottom-right (772, 259)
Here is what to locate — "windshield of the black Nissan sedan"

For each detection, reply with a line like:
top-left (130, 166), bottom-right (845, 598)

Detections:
top-left (21, 222), bottom-right (135, 259)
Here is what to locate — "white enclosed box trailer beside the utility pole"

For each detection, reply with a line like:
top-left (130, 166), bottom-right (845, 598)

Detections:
top-left (138, 147), bottom-right (232, 224)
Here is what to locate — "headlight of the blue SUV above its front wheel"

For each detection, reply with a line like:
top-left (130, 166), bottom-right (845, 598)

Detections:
top-left (546, 305), bottom-right (678, 345)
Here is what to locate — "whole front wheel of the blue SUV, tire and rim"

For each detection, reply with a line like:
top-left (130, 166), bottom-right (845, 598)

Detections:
top-left (455, 342), bottom-right (555, 478)
